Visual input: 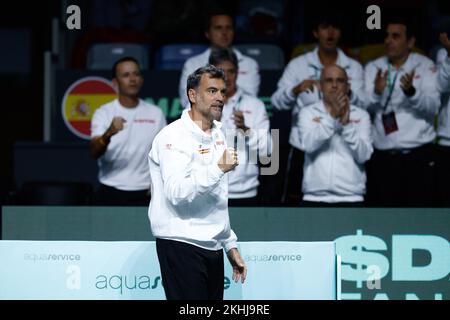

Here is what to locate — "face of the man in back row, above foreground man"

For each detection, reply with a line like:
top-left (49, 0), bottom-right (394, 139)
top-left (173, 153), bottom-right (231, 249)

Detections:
top-left (205, 15), bottom-right (234, 48)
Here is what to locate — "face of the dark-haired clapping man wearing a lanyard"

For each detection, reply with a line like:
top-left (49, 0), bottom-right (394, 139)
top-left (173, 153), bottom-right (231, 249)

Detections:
top-left (384, 24), bottom-right (415, 59)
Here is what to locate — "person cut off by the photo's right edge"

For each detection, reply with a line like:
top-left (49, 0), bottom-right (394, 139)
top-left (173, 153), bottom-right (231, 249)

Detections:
top-left (436, 33), bottom-right (450, 207)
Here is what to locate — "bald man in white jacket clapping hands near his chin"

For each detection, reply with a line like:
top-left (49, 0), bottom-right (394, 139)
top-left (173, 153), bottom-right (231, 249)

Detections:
top-left (298, 65), bottom-right (373, 206)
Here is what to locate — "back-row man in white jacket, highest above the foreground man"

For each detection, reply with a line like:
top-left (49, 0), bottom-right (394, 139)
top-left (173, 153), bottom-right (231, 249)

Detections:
top-left (178, 12), bottom-right (261, 108)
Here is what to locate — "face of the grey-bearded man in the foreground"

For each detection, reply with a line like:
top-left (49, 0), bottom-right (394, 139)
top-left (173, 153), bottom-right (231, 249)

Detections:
top-left (189, 73), bottom-right (226, 121)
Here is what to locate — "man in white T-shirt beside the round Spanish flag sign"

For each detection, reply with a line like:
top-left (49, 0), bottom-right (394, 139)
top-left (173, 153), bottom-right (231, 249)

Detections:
top-left (90, 57), bottom-right (166, 206)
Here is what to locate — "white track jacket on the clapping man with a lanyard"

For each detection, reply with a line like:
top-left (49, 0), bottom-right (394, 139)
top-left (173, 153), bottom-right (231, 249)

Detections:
top-left (364, 53), bottom-right (440, 150)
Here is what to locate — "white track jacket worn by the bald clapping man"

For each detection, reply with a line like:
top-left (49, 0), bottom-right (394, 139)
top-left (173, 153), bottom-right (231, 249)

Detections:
top-left (298, 101), bottom-right (373, 202)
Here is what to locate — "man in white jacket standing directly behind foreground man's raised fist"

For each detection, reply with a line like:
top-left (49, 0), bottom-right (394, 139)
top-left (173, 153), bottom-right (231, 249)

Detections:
top-left (209, 49), bottom-right (271, 207)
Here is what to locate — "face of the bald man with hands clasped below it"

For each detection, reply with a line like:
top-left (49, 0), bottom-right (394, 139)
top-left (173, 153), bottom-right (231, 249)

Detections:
top-left (320, 66), bottom-right (350, 101)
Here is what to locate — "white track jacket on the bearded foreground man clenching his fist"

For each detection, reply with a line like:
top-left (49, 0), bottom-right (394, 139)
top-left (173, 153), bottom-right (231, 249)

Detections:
top-left (148, 110), bottom-right (237, 251)
